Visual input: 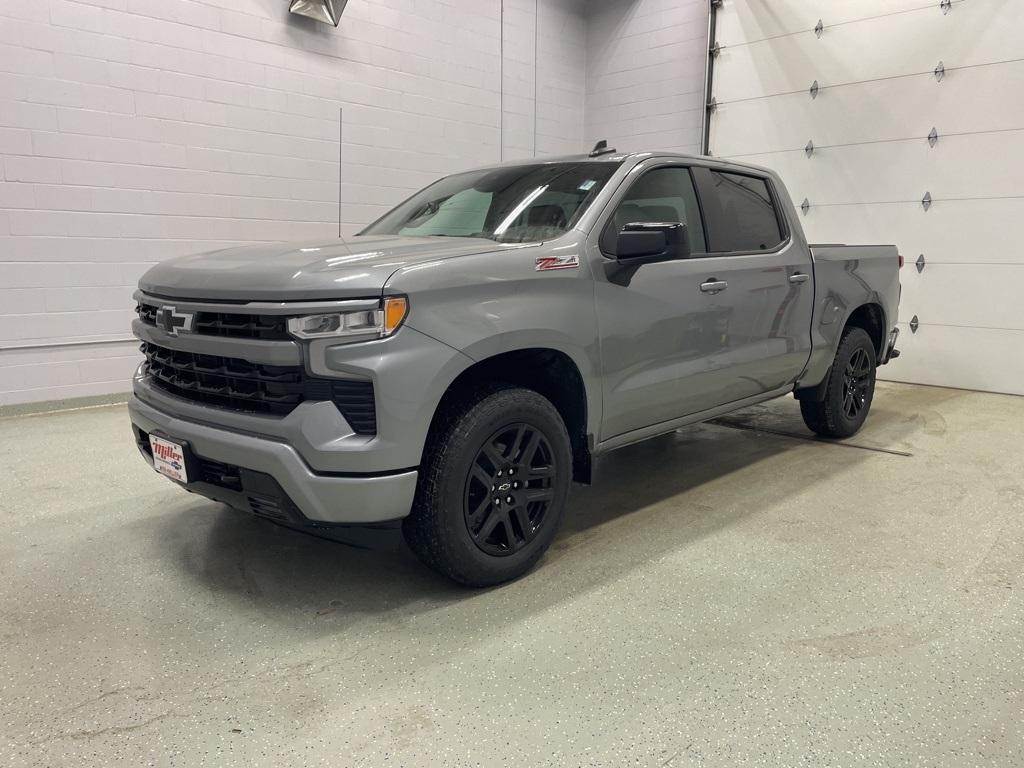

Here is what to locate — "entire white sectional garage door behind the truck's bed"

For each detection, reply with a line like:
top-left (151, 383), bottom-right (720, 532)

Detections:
top-left (709, 0), bottom-right (1024, 394)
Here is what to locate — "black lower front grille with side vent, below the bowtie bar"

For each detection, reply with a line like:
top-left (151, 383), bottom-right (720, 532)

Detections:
top-left (139, 342), bottom-right (377, 434)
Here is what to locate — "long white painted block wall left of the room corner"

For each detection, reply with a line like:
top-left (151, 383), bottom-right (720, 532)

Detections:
top-left (0, 0), bottom-right (587, 404)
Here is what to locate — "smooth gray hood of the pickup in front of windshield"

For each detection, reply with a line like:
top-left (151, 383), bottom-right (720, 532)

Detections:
top-left (139, 236), bottom-right (508, 301)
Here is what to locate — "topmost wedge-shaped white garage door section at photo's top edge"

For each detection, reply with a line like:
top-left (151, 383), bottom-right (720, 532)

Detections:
top-left (716, 0), bottom-right (942, 44)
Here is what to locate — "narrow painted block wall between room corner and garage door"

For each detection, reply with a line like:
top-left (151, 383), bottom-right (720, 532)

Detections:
top-left (585, 0), bottom-right (708, 154)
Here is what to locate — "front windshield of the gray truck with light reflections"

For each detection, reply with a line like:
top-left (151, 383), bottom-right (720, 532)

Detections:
top-left (359, 162), bottom-right (618, 243)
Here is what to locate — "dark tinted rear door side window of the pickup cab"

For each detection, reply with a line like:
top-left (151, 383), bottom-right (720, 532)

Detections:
top-left (693, 168), bottom-right (785, 253)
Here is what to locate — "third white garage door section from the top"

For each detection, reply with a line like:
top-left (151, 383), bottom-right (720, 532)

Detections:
top-left (711, 61), bottom-right (1024, 159)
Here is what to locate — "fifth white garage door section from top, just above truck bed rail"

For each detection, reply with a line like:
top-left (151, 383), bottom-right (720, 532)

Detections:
top-left (791, 198), bottom-right (1024, 268)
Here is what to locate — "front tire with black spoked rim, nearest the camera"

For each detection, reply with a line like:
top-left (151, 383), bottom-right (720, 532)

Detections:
top-left (402, 385), bottom-right (572, 587)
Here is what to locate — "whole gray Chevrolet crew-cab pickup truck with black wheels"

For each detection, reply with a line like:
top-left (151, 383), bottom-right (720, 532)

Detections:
top-left (129, 150), bottom-right (901, 586)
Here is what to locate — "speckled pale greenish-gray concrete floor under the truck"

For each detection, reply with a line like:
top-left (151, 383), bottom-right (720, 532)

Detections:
top-left (0, 384), bottom-right (1024, 768)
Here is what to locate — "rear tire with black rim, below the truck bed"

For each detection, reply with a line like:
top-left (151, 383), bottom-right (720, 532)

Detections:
top-left (800, 328), bottom-right (876, 437)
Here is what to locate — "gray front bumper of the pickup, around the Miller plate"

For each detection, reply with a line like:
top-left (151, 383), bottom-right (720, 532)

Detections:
top-left (128, 396), bottom-right (418, 524)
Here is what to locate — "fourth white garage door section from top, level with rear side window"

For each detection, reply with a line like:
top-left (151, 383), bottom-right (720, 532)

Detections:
top-left (743, 130), bottom-right (1024, 205)
